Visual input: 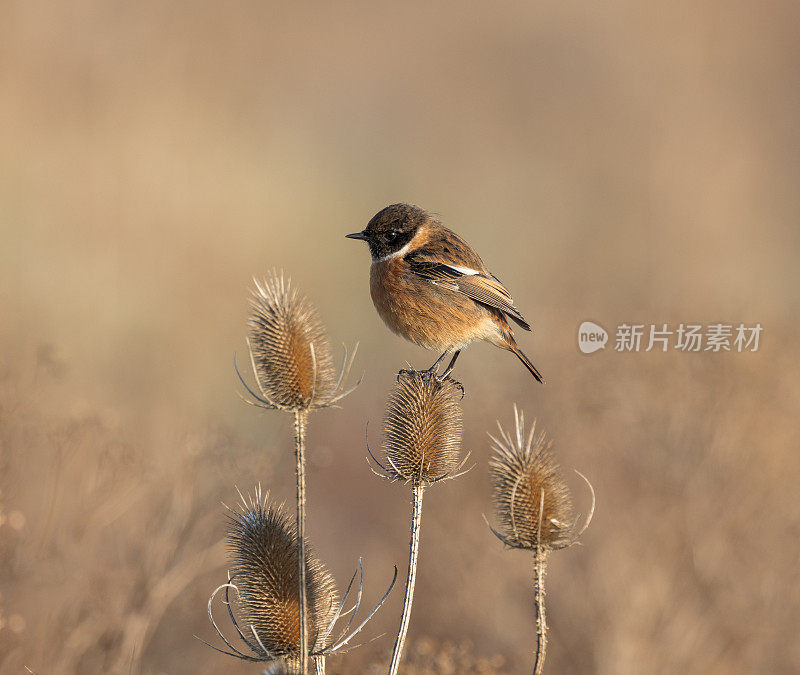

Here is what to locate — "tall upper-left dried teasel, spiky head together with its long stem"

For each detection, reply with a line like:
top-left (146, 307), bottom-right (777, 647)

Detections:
top-left (234, 272), bottom-right (357, 673)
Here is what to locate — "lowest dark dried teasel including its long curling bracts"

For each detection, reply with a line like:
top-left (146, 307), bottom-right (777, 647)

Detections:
top-left (202, 487), bottom-right (397, 675)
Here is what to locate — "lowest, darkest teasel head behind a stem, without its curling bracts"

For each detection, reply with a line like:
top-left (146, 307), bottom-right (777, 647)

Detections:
top-left (228, 489), bottom-right (339, 667)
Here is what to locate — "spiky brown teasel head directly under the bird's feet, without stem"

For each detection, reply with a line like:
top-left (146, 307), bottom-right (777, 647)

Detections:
top-left (373, 370), bottom-right (466, 487)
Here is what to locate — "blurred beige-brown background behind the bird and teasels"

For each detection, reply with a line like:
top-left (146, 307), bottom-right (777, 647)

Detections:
top-left (0, 0), bottom-right (800, 674)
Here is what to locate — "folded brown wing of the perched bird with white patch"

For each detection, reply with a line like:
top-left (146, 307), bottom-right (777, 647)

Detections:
top-left (405, 228), bottom-right (531, 330)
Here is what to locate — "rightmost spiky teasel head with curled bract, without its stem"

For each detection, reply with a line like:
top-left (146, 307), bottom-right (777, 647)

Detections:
top-left (489, 406), bottom-right (594, 551)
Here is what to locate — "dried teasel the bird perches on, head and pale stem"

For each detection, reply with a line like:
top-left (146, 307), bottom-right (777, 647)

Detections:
top-left (367, 370), bottom-right (467, 675)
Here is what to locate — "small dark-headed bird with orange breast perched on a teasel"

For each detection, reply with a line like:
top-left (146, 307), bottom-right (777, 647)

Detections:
top-left (345, 204), bottom-right (544, 383)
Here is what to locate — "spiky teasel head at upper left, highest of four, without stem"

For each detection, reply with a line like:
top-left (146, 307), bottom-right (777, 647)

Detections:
top-left (237, 272), bottom-right (355, 410)
